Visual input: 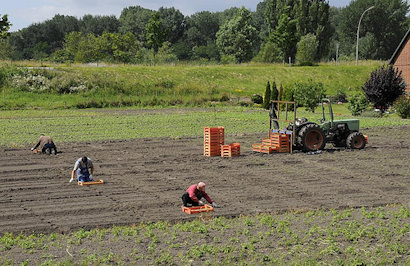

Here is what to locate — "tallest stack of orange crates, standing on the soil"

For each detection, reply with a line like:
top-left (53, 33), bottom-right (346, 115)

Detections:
top-left (204, 127), bottom-right (225, 157)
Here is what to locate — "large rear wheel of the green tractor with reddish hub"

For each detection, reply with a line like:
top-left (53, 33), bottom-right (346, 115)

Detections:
top-left (297, 124), bottom-right (326, 152)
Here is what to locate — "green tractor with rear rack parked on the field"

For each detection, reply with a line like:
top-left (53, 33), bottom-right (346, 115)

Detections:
top-left (270, 99), bottom-right (367, 152)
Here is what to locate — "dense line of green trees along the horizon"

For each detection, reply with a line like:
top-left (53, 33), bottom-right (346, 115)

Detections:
top-left (0, 0), bottom-right (410, 64)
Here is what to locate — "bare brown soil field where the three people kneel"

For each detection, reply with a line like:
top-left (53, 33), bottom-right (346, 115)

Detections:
top-left (0, 126), bottom-right (410, 233)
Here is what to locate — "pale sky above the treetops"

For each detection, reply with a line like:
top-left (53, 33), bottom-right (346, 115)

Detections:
top-left (0, 0), bottom-right (351, 32)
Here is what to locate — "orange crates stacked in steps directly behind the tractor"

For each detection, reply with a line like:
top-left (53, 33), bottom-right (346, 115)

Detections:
top-left (252, 133), bottom-right (290, 153)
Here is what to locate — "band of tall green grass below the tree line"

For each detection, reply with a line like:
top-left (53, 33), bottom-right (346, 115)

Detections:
top-left (0, 61), bottom-right (382, 109)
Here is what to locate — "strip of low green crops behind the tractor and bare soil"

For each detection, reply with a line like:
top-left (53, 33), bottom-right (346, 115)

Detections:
top-left (0, 106), bottom-right (410, 147)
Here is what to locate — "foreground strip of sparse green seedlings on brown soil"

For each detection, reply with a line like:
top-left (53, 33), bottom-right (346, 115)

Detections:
top-left (0, 206), bottom-right (410, 265)
